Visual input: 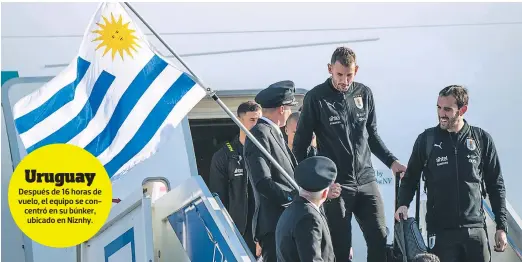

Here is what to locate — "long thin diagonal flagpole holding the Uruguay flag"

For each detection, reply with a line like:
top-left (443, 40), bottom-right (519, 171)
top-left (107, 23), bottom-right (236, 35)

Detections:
top-left (125, 2), bottom-right (299, 190)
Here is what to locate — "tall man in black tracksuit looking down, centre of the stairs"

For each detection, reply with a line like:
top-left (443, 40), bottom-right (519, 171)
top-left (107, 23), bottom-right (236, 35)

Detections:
top-left (293, 47), bottom-right (406, 262)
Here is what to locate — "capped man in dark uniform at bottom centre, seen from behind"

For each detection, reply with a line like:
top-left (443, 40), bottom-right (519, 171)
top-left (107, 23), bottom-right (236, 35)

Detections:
top-left (276, 156), bottom-right (337, 262)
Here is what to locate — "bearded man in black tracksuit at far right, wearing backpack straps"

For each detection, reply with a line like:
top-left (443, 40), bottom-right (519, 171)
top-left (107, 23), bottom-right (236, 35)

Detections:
top-left (395, 85), bottom-right (507, 262)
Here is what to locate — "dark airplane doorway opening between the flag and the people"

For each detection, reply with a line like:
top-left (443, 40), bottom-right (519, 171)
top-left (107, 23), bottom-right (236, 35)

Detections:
top-left (189, 118), bottom-right (239, 185)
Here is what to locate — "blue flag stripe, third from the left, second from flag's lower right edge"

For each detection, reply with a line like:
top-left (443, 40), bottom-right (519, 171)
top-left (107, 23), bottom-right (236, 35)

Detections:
top-left (85, 55), bottom-right (167, 157)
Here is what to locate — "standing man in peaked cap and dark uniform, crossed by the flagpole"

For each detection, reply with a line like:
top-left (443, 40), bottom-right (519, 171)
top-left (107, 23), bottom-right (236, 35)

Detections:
top-left (243, 81), bottom-right (297, 262)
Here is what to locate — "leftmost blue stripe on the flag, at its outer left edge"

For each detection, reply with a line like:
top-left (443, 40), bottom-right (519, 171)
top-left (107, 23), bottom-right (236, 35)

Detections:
top-left (15, 57), bottom-right (91, 134)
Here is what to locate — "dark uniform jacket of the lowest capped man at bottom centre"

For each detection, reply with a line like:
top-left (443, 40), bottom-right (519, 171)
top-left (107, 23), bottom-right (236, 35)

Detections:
top-left (276, 197), bottom-right (335, 262)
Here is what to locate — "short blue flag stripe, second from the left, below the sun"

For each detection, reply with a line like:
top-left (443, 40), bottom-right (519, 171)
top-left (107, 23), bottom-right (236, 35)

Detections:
top-left (27, 71), bottom-right (115, 153)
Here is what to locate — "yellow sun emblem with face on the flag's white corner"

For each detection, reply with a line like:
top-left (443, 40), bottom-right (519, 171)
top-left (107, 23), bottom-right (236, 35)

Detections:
top-left (92, 13), bottom-right (140, 60)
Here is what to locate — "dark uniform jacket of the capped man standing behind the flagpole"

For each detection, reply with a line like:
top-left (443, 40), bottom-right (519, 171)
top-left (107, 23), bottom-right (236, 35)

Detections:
top-left (243, 118), bottom-right (297, 239)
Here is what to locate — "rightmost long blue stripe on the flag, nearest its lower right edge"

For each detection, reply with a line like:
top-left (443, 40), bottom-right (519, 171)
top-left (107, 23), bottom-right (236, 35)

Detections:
top-left (105, 73), bottom-right (195, 177)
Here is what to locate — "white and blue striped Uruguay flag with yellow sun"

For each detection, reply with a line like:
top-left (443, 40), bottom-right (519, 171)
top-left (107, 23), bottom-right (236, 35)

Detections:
top-left (13, 3), bottom-right (206, 180)
